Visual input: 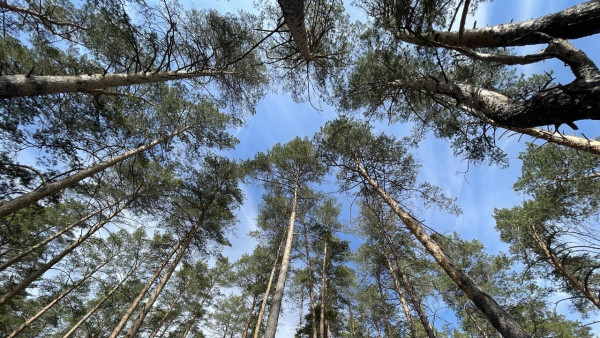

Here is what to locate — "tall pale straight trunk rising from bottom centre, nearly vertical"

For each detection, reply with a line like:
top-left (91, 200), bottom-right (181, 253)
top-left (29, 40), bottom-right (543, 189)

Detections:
top-left (265, 176), bottom-right (299, 338)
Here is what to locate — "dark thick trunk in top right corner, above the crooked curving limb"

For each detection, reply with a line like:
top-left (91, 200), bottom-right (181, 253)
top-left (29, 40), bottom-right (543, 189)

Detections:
top-left (396, 1), bottom-right (600, 48)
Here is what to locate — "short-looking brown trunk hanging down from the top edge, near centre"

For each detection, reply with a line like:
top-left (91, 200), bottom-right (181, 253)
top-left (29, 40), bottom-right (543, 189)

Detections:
top-left (277, 0), bottom-right (314, 61)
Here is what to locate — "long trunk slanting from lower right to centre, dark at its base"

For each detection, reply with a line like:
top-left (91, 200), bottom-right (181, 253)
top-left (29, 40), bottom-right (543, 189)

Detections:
top-left (356, 162), bottom-right (529, 338)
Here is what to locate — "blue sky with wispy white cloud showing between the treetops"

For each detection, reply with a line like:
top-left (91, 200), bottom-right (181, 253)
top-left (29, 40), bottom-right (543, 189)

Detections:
top-left (194, 0), bottom-right (600, 337)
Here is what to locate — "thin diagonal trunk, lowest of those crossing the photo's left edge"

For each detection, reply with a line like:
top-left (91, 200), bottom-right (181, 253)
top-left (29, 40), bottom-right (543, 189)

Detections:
top-left (0, 198), bottom-right (134, 305)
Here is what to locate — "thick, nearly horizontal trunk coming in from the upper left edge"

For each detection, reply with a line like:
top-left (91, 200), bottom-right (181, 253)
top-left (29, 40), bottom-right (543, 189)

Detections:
top-left (0, 70), bottom-right (235, 98)
